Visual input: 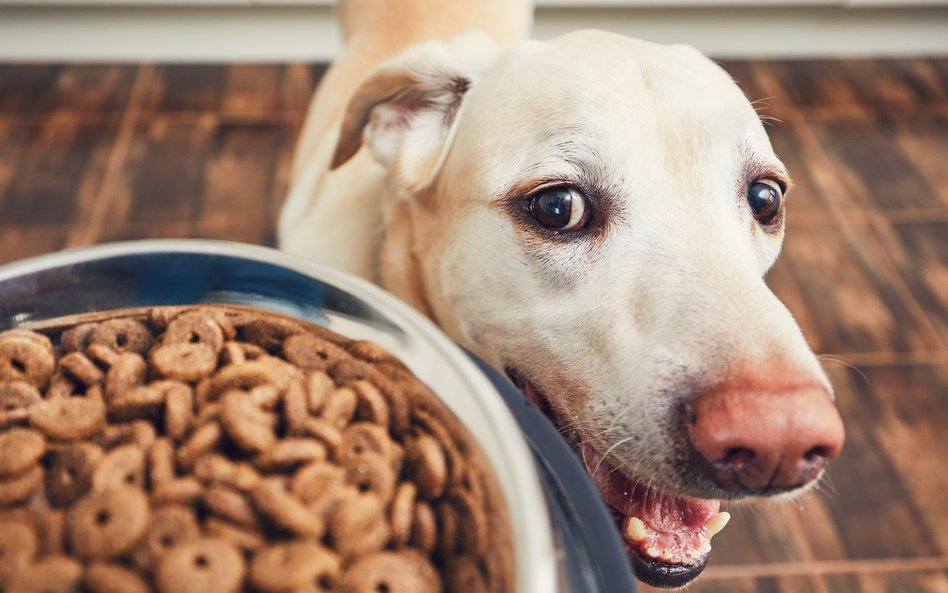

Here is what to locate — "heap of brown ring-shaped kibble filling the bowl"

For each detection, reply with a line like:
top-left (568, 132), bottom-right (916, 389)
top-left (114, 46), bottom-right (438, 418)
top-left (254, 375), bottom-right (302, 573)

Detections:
top-left (0, 306), bottom-right (512, 593)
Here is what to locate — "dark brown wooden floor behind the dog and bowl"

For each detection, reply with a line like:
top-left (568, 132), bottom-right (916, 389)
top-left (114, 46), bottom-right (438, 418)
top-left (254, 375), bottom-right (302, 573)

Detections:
top-left (0, 59), bottom-right (948, 593)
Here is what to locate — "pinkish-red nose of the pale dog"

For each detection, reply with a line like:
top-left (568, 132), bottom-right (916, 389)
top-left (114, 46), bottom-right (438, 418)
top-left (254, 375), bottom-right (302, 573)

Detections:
top-left (687, 384), bottom-right (845, 494)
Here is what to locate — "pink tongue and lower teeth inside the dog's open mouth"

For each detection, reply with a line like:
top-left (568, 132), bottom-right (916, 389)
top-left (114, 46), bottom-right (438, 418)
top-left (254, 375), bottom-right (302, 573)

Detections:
top-left (580, 443), bottom-right (730, 565)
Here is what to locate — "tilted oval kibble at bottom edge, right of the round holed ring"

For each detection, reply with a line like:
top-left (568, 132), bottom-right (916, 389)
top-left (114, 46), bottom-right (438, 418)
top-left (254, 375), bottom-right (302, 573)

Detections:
top-left (249, 541), bottom-right (341, 593)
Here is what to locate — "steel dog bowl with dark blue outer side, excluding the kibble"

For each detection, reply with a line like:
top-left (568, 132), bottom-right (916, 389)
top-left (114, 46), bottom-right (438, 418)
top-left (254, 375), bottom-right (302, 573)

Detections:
top-left (0, 240), bottom-right (635, 593)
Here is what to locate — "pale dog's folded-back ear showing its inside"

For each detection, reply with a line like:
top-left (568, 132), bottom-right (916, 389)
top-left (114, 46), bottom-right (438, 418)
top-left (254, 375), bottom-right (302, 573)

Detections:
top-left (331, 33), bottom-right (497, 191)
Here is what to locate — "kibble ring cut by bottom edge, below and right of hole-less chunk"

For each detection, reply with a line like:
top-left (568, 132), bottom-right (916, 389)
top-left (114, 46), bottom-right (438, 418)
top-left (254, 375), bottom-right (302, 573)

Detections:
top-left (341, 550), bottom-right (442, 593)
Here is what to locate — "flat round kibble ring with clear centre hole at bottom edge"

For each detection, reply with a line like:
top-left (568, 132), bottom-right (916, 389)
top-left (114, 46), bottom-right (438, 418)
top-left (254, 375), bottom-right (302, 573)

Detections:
top-left (155, 538), bottom-right (246, 593)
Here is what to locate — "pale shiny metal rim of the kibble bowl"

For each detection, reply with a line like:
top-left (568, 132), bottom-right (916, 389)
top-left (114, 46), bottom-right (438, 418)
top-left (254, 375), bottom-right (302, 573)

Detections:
top-left (0, 239), bottom-right (562, 593)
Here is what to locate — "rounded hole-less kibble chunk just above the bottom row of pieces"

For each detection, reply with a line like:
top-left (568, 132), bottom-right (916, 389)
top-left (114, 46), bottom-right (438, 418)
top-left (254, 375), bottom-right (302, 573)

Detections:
top-left (329, 493), bottom-right (389, 559)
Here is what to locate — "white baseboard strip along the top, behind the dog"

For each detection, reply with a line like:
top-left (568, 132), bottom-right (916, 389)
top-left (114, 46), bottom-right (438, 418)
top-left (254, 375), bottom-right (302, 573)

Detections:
top-left (0, 0), bottom-right (948, 62)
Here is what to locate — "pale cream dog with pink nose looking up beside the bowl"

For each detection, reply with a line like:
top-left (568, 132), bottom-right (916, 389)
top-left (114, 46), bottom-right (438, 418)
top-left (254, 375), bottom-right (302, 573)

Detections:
top-left (278, 0), bottom-right (844, 587)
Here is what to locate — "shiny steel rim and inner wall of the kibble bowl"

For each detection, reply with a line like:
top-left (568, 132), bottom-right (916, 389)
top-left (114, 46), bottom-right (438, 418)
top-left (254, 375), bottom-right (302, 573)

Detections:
top-left (0, 240), bottom-right (566, 593)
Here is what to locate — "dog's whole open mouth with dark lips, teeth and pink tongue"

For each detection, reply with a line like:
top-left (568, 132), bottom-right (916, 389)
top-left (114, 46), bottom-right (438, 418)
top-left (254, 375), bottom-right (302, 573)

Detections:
top-left (506, 368), bottom-right (730, 588)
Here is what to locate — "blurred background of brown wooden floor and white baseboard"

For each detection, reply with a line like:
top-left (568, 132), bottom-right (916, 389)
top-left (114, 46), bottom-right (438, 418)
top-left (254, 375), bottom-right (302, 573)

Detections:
top-left (0, 0), bottom-right (948, 593)
